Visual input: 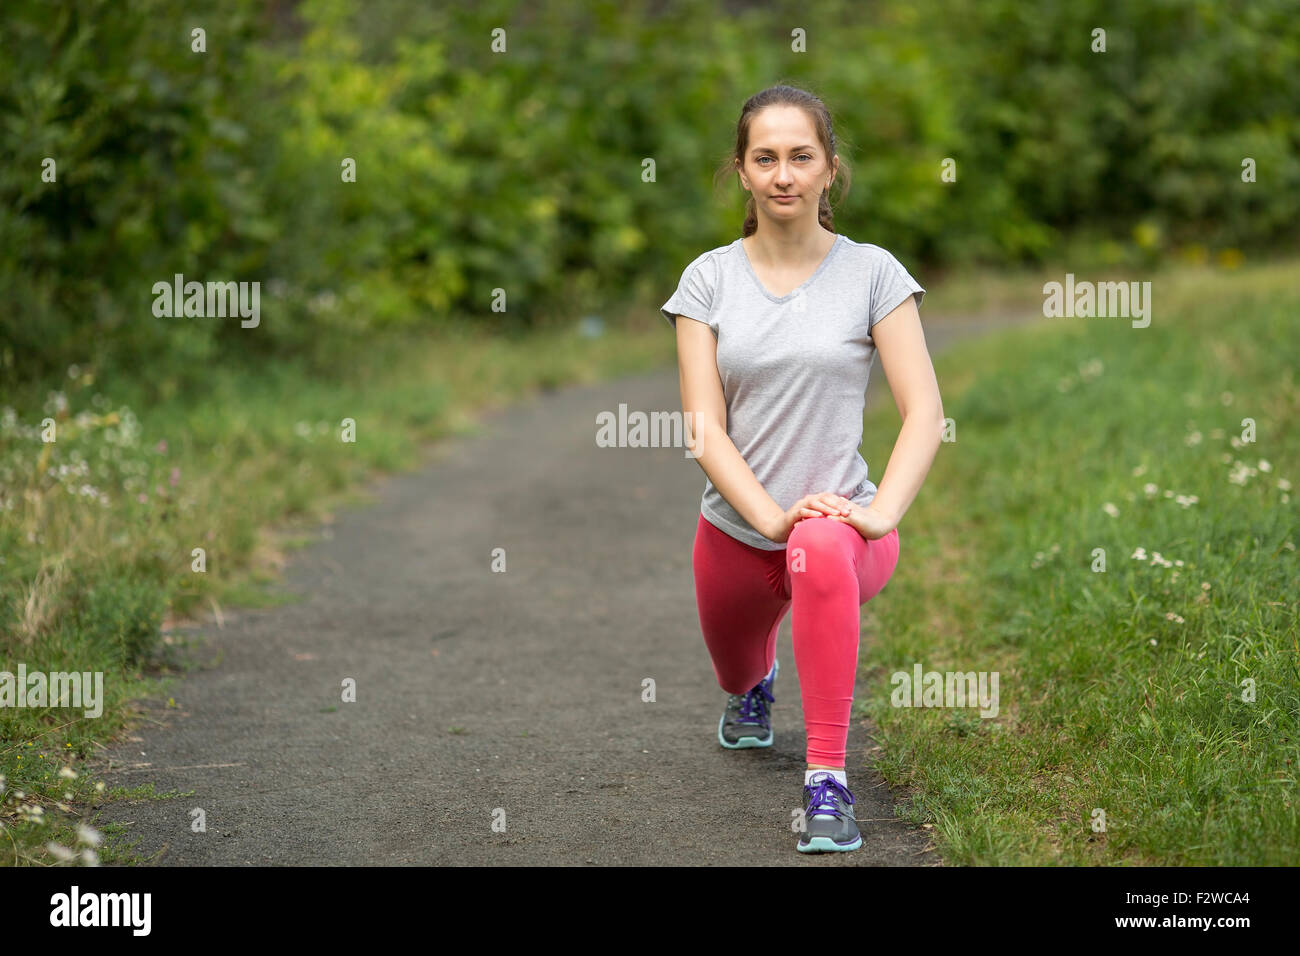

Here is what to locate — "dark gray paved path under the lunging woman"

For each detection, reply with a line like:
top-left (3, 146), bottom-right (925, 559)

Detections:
top-left (98, 310), bottom-right (1040, 865)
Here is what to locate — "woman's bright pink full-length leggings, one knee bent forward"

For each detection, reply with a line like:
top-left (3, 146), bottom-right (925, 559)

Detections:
top-left (692, 515), bottom-right (898, 767)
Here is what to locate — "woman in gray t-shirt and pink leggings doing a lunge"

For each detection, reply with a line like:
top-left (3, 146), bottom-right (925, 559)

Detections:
top-left (662, 86), bottom-right (944, 852)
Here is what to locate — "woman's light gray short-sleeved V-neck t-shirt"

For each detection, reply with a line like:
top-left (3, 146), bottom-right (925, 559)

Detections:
top-left (660, 234), bottom-right (926, 551)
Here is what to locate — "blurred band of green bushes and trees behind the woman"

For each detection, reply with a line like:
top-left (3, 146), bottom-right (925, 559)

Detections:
top-left (0, 0), bottom-right (1300, 397)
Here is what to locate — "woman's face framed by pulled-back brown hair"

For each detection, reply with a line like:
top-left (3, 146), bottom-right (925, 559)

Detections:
top-left (740, 105), bottom-right (835, 221)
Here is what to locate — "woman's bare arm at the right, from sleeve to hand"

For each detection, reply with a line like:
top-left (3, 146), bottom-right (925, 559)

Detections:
top-left (846, 295), bottom-right (944, 537)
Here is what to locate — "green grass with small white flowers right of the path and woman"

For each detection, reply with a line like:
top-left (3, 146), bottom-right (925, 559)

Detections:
top-left (858, 264), bottom-right (1300, 865)
